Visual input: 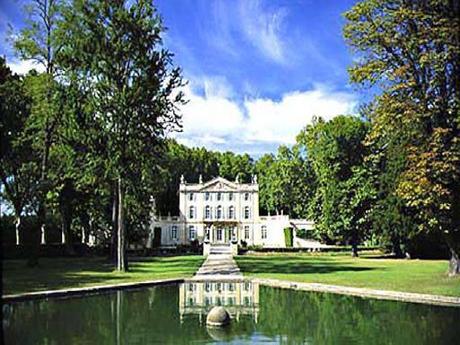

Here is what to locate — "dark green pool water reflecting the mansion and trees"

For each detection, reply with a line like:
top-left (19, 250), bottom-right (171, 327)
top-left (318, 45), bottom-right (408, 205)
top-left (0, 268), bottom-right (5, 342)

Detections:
top-left (3, 282), bottom-right (460, 345)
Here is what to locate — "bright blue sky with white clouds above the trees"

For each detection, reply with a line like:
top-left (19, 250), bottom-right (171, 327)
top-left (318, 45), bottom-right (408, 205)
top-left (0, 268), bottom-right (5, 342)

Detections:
top-left (0, 0), bottom-right (362, 157)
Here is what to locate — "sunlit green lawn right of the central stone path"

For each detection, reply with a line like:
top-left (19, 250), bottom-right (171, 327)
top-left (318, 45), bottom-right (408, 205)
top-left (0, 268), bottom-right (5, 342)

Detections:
top-left (236, 253), bottom-right (460, 296)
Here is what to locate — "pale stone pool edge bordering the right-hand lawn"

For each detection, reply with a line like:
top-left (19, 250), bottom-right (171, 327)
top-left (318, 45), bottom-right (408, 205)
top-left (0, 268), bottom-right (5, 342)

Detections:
top-left (252, 278), bottom-right (460, 307)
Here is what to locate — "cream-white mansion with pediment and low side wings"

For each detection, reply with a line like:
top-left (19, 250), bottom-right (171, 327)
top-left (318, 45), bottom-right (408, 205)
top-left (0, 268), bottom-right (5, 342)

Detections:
top-left (147, 176), bottom-right (313, 248)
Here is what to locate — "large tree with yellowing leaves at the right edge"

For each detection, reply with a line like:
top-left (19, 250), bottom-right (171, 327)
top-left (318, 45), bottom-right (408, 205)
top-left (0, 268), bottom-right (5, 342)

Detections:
top-left (344, 0), bottom-right (460, 275)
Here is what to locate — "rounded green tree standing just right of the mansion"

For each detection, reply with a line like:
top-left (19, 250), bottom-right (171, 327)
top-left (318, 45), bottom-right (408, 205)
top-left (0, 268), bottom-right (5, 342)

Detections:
top-left (299, 115), bottom-right (373, 256)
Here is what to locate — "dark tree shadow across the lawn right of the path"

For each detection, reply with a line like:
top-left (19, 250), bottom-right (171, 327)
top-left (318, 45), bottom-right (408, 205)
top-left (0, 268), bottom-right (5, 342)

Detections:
top-left (238, 259), bottom-right (378, 274)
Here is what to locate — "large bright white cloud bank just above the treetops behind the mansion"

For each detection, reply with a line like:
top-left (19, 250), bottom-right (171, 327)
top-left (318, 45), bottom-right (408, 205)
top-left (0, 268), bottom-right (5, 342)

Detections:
top-left (176, 78), bottom-right (356, 153)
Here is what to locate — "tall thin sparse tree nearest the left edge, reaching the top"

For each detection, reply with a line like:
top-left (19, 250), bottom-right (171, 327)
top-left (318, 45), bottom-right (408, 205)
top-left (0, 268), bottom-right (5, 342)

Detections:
top-left (14, 0), bottom-right (61, 266)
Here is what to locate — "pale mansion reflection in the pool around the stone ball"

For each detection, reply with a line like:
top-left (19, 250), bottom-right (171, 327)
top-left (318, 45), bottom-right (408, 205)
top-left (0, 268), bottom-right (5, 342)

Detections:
top-left (179, 280), bottom-right (259, 323)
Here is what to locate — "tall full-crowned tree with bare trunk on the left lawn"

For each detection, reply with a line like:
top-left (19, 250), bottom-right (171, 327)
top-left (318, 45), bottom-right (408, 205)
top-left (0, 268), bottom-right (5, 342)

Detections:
top-left (59, 0), bottom-right (184, 271)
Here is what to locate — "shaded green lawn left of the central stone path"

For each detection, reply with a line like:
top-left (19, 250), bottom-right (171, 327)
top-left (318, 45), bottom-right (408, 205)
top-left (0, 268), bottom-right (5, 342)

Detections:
top-left (2, 256), bottom-right (203, 295)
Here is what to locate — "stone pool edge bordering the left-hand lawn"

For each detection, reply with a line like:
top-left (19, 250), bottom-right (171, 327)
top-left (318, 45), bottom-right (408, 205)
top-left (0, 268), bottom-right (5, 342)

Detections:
top-left (1, 278), bottom-right (185, 303)
